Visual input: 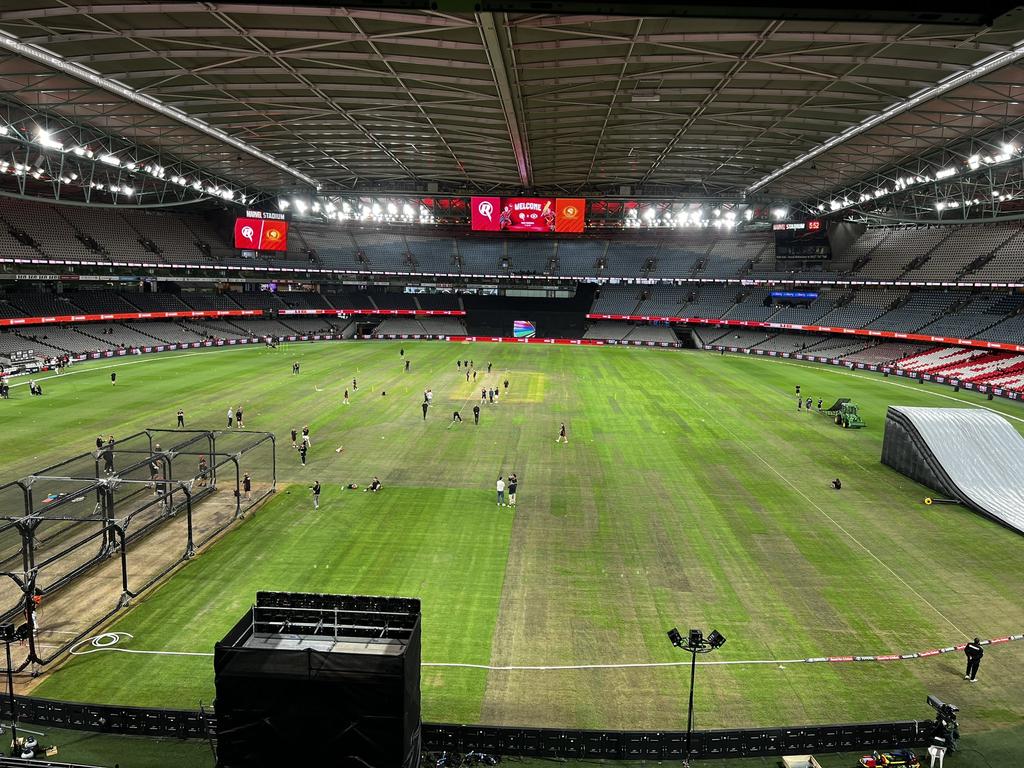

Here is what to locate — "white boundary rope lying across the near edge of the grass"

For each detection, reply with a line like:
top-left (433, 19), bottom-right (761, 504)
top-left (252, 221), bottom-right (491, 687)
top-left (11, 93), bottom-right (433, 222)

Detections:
top-left (70, 632), bottom-right (1024, 672)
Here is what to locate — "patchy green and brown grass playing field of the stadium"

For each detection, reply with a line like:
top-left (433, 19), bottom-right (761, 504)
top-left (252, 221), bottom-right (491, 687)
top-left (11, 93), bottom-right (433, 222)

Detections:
top-left (0, 342), bottom-right (1024, 752)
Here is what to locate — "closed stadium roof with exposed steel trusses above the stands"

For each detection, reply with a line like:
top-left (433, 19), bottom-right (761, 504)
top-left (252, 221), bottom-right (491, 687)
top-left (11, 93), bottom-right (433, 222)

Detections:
top-left (0, 0), bottom-right (1024, 214)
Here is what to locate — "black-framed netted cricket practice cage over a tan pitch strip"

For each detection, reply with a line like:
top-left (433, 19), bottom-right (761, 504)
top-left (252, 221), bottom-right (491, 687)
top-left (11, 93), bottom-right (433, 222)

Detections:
top-left (0, 429), bottom-right (276, 670)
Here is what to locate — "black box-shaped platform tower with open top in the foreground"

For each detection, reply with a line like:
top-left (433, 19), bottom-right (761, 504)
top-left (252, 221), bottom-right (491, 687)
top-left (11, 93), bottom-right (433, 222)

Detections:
top-left (214, 592), bottom-right (421, 768)
